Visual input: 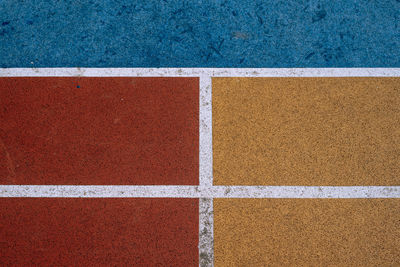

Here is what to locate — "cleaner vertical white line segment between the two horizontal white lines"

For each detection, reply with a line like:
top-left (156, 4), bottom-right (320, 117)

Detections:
top-left (199, 75), bottom-right (213, 188)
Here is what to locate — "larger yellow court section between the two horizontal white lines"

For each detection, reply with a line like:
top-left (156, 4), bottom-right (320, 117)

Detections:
top-left (212, 77), bottom-right (400, 186)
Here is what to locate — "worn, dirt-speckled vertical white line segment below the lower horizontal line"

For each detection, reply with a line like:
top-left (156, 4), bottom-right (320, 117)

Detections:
top-left (199, 198), bottom-right (214, 267)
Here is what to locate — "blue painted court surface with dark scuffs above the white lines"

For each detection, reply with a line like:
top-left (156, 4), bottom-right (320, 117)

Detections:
top-left (0, 0), bottom-right (400, 67)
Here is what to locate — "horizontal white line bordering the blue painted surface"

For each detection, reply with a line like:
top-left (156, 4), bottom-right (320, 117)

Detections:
top-left (0, 68), bottom-right (400, 77)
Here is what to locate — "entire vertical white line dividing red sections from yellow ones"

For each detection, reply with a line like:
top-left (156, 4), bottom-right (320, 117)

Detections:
top-left (199, 74), bottom-right (214, 267)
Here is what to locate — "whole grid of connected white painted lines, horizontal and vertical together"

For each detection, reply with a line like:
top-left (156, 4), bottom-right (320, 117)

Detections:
top-left (0, 68), bottom-right (400, 266)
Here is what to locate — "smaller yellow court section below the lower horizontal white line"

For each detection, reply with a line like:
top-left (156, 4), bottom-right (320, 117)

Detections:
top-left (214, 199), bottom-right (400, 267)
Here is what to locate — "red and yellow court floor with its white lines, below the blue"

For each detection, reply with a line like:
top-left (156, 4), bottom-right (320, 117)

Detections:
top-left (0, 68), bottom-right (400, 266)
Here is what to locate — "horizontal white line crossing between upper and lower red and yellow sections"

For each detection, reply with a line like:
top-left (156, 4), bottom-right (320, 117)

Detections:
top-left (0, 185), bottom-right (400, 198)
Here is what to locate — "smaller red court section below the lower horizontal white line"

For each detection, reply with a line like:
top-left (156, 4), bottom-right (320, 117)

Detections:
top-left (0, 198), bottom-right (199, 267)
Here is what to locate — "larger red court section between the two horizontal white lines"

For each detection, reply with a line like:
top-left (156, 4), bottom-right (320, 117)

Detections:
top-left (0, 77), bottom-right (199, 185)
